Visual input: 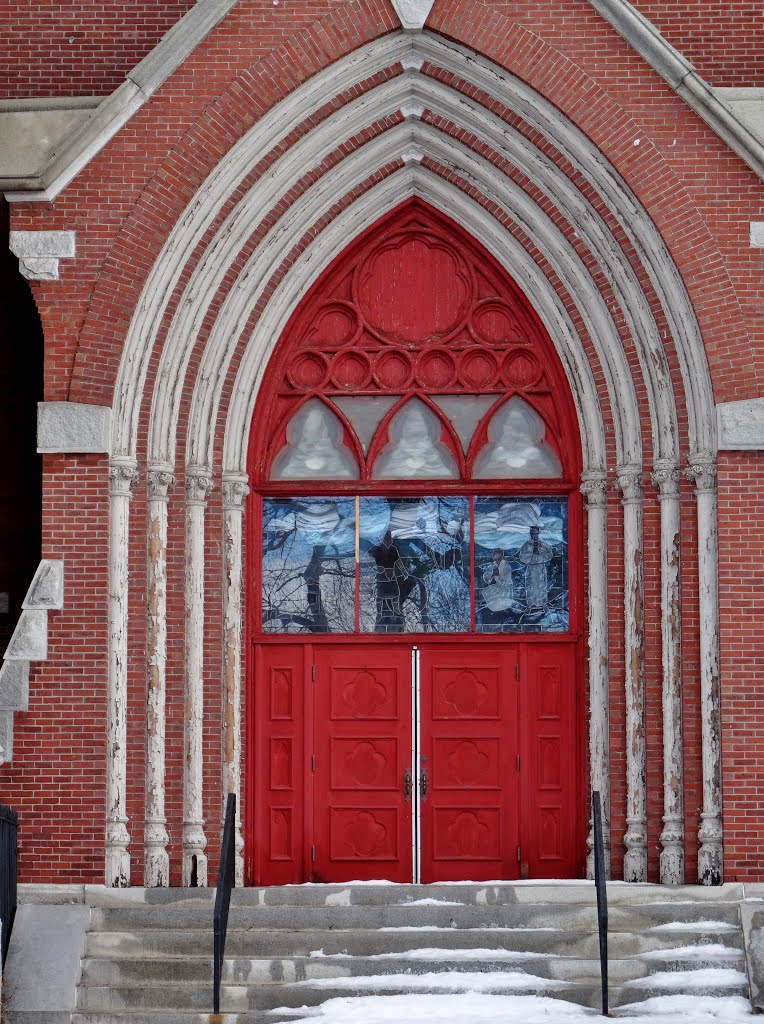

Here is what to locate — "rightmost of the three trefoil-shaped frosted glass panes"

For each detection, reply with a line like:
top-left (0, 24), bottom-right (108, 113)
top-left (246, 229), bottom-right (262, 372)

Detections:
top-left (472, 395), bottom-right (562, 479)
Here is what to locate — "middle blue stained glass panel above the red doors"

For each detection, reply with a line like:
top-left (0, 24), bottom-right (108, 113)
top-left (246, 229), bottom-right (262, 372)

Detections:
top-left (359, 497), bottom-right (470, 633)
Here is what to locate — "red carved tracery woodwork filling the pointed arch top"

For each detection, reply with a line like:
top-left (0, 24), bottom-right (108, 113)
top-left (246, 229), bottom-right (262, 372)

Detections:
top-left (250, 200), bottom-right (580, 489)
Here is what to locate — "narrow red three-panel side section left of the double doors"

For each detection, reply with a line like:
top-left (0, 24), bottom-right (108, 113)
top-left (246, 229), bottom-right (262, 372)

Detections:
top-left (252, 644), bottom-right (305, 885)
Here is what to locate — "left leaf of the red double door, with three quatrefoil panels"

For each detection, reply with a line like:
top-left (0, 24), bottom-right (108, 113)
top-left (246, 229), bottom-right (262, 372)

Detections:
top-left (310, 643), bottom-right (413, 882)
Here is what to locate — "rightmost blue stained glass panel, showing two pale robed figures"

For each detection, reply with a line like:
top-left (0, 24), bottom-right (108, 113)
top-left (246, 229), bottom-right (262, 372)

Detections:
top-left (474, 497), bottom-right (569, 633)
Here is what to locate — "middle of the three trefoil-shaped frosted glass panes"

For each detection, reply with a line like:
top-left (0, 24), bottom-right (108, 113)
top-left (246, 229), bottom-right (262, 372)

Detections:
top-left (372, 398), bottom-right (459, 480)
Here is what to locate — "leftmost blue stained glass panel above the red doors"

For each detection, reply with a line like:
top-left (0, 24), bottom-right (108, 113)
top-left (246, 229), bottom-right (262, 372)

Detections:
top-left (262, 498), bottom-right (355, 633)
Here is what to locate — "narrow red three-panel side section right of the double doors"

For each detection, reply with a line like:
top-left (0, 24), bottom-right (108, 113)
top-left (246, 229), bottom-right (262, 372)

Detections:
top-left (520, 643), bottom-right (582, 879)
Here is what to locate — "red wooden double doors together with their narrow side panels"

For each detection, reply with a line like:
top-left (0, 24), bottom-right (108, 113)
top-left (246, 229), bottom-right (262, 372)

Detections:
top-left (246, 639), bottom-right (583, 885)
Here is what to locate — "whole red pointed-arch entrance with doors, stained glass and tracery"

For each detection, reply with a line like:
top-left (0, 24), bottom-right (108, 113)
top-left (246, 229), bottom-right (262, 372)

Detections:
top-left (244, 202), bottom-right (585, 885)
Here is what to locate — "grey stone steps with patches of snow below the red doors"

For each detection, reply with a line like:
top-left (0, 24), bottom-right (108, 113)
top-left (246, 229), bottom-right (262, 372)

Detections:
top-left (65, 883), bottom-right (748, 1024)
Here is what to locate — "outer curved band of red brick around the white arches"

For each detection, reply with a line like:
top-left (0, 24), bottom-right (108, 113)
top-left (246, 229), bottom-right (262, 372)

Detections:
top-left (70, 3), bottom-right (756, 419)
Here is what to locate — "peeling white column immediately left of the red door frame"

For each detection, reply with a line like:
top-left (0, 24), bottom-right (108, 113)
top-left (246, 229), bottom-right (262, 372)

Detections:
top-left (222, 474), bottom-right (249, 886)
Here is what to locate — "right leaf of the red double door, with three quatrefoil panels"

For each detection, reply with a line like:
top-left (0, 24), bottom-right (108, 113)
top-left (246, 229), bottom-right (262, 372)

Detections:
top-left (420, 642), bottom-right (518, 882)
